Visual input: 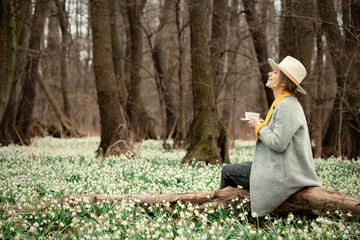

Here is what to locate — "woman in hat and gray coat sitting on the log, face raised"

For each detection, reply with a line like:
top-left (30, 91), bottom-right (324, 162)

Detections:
top-left (220, 56), bottom-right (321, 217)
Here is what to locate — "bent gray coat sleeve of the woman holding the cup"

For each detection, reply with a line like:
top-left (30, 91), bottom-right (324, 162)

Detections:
top-left (259, 103), bottom-right (301, 153)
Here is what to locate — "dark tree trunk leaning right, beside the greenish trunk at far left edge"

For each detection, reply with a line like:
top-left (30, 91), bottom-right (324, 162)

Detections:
top-left (16, 0), bottom-right (48, 144)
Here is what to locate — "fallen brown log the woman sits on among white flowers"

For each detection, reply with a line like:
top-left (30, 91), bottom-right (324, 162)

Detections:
top-left (59, 187), bottom-right (360, 219)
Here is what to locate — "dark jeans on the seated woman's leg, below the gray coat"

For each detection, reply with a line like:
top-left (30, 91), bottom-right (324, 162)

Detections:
top-left (220, 162), bottom-right (252, 189)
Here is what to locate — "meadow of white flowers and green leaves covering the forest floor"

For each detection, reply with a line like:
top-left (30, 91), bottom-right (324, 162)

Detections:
top-left (0, 137), bottom-right (360, 240)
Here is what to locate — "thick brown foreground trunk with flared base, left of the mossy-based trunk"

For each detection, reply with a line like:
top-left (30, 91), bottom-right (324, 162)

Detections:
top-left (90, 0), bottom-right (131, 156)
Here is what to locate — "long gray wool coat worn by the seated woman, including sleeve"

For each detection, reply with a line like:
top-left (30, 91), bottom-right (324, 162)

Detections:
top-left (250, 96), bottom-right (321, 216)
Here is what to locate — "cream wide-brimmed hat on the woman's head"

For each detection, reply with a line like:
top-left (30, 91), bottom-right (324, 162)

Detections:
top-left (268, 56), bottom-right (306, 94)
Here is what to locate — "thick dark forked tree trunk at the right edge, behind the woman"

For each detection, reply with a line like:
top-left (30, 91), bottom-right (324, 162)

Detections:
top-left (318, 0), bottom-right (360, 159)
